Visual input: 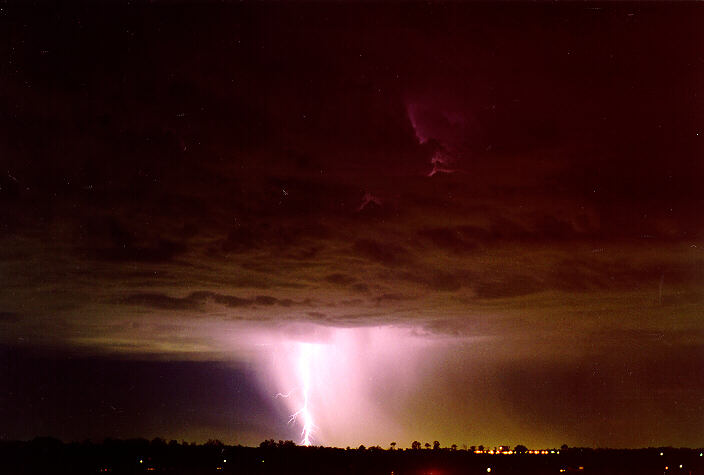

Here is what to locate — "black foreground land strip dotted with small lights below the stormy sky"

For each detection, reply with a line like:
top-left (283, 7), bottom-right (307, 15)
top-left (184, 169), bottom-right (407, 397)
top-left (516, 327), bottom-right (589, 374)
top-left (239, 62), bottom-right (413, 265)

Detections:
top-left (0, 439), bottom-right (704, 475)
